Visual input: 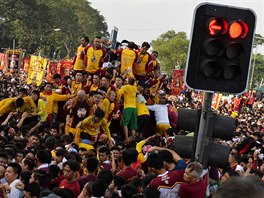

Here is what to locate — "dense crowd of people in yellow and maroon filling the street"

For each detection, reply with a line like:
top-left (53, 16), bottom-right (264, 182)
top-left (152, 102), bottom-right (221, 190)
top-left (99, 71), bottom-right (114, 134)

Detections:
top-left (0, 36), bottom-right (264, 198)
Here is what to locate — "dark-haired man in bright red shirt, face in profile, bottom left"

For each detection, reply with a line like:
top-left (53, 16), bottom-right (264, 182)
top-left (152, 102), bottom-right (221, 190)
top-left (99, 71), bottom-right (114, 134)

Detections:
top-left (59, 160), bottom-right (81, 198)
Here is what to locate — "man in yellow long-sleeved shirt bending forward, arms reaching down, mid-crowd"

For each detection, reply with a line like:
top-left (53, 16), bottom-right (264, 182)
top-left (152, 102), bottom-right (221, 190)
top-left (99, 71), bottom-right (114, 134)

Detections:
top-left (74, 108), bottom-right (112, 147)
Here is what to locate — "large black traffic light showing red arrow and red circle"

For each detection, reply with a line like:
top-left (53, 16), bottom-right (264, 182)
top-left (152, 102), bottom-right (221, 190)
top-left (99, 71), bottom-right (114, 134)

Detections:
top-left (185, 3), bottom-right (255, 93)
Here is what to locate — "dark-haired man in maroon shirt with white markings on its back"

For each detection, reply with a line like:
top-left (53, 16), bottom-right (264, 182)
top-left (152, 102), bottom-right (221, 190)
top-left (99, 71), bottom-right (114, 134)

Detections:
top-left (147, 153), bottom-right (184, 198)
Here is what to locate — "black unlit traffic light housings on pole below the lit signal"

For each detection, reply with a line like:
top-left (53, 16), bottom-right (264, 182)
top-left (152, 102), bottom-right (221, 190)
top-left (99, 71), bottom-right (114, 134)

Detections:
top-left (173, 109), bottom-right (236, 168)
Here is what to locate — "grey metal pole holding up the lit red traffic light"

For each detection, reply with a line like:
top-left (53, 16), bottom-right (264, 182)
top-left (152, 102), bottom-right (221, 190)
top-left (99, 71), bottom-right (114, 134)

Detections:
top-left (195, 92), bottom-right (213, 163)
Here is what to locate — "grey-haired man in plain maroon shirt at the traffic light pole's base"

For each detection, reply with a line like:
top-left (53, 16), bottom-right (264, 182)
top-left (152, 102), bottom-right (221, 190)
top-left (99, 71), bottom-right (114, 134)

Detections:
top-left (179, 162), bottom-right (206, 198)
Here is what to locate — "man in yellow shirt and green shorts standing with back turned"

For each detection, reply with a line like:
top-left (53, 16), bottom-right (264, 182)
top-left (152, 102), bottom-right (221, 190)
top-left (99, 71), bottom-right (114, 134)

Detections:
top-left (117, 77), bottom-right (137, 141)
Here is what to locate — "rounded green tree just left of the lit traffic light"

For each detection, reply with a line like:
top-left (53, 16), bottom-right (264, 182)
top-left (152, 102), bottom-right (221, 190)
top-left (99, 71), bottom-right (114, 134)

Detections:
top-left (151, 30), bottom-right (189, 74)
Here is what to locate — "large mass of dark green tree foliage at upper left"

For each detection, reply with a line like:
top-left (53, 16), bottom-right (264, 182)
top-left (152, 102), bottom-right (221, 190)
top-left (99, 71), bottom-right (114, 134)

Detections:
top-left (0, 0), bottom-right (109, 58)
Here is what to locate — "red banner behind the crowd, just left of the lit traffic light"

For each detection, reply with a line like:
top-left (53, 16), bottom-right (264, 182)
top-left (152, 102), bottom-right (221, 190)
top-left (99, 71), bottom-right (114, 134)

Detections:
top-left (171, 69), bottom-right (184, 95)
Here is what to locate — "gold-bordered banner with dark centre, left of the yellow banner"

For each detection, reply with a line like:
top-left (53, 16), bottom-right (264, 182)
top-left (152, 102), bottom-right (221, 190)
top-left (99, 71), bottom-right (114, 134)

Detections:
top-left (6, 50), bottom-right (22, 73)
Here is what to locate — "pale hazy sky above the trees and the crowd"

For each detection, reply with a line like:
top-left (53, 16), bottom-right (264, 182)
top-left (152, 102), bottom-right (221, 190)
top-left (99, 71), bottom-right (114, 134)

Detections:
top-left (88, 0), bottom-right (264, 54)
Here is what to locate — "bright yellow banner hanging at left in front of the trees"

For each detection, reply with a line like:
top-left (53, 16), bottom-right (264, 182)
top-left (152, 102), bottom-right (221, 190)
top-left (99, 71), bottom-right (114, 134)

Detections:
top-left (27, 55), bottom-right (48, 86)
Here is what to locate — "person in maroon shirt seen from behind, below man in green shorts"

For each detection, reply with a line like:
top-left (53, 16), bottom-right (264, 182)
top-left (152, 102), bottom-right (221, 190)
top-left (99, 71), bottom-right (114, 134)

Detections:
top-left (117, 149), bottom-right (137, 181)
